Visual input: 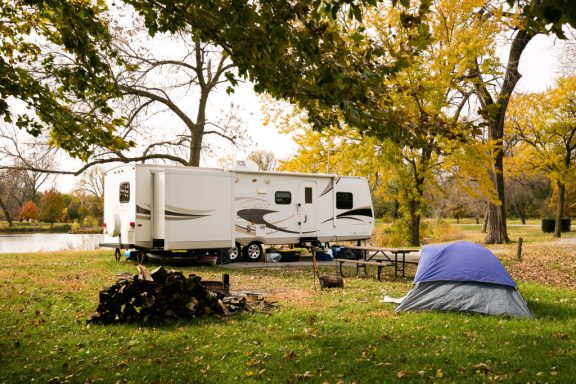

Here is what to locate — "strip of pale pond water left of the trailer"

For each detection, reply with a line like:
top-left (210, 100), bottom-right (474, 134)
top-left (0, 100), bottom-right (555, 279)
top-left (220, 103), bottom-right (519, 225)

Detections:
top-left (0, 233), bottom-right (103, 253)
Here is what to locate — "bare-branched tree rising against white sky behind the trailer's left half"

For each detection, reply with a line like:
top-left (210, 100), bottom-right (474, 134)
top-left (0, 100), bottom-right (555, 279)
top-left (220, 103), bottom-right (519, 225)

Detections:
top-left (104, 6), bottom-right (246, 166)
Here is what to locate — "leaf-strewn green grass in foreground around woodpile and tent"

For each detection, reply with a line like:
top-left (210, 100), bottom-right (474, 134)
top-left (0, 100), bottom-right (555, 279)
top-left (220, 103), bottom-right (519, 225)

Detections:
top-left (0, 251), bottom-right (576, 383)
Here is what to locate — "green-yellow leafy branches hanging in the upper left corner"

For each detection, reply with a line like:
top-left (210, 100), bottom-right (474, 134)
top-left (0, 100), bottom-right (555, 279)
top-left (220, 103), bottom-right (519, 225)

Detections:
top-left (0, 0), bottom-right (127, 159)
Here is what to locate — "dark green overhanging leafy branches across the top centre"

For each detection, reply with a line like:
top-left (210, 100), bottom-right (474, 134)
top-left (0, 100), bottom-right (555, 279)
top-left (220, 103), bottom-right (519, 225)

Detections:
top-left (122, 0), bottom-right (428, 140)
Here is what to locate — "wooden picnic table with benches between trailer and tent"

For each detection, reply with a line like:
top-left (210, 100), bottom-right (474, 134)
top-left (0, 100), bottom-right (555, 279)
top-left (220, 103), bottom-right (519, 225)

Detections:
top-left (334, 246), bottom-right (420, 280)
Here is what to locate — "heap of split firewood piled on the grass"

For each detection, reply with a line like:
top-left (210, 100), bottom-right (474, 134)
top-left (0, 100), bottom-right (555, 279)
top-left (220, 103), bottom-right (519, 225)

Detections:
top-left (88, 265), bottom-right (274, 324)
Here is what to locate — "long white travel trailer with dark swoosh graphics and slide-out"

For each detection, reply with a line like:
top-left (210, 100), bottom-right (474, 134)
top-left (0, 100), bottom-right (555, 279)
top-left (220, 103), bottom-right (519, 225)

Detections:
top-left (101, 164), bottom-right (374, 261)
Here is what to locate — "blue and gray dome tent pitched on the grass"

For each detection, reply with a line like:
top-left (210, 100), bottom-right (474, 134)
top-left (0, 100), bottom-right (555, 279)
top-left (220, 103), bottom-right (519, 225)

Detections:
top-left (396, 241), bottom-right (532, 318)
